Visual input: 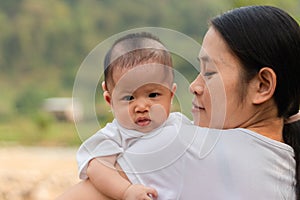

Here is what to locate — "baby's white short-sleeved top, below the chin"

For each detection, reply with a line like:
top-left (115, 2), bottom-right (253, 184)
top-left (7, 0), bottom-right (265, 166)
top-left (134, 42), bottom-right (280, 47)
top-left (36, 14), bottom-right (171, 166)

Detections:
top-left (77, 112), bottom-right (191, 179)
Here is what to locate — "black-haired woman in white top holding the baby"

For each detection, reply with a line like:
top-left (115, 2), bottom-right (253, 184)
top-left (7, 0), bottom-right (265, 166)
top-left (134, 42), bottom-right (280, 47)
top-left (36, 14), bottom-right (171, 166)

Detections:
top-left (56, 6), bottom-right (300, 200)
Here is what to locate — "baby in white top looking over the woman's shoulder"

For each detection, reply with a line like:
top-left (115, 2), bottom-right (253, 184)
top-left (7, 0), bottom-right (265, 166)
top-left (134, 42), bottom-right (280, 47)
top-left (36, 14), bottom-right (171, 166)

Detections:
top-left (77, 32), bottom-right (191, 199)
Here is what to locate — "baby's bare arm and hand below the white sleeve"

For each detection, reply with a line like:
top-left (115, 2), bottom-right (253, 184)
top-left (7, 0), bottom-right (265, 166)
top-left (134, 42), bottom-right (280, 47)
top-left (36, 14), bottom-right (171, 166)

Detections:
top-left (87, 155), bottom-right (157, 200)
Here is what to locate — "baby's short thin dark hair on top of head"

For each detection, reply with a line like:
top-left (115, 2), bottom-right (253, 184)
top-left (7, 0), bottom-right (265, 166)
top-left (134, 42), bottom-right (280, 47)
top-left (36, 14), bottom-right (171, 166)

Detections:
top-left (104, 32), bottom-right (174, 90)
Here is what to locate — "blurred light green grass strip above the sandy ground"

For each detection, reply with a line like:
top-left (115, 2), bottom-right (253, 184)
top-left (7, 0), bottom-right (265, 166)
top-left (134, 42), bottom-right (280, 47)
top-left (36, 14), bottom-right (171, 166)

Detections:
top-left (0, 118), bottom-right (81, 146)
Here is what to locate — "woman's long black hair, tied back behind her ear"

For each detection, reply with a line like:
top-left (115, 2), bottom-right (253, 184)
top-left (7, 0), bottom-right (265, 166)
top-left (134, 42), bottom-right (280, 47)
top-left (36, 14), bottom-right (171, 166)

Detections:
top-left (210, 6), bottom-right (300, 200)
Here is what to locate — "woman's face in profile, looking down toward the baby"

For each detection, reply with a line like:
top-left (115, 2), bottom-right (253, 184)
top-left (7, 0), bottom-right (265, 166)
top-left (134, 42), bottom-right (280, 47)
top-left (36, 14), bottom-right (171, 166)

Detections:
top-left (190, 27), bottom-right (251, 128)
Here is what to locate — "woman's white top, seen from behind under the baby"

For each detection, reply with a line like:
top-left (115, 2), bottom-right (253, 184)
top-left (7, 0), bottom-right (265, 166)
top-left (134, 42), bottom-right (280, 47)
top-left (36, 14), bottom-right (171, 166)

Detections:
top-left (118, 125), bottom-right (296, 200)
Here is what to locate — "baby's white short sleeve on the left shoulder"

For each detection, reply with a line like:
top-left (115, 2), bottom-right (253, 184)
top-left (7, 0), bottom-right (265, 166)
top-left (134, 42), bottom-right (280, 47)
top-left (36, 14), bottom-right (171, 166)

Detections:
top-left (76, 124), bottom-right (124, 179)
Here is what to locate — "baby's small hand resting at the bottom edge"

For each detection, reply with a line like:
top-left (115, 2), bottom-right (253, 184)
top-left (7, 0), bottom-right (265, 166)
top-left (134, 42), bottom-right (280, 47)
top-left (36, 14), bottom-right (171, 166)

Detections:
top-left (123, 184), bottom-right (158, 200)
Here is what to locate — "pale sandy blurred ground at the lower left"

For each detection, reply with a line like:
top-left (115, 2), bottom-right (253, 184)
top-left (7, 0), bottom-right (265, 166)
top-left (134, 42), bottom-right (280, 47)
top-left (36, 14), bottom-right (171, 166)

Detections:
top-left (0, 146), bottom-right (79, 200)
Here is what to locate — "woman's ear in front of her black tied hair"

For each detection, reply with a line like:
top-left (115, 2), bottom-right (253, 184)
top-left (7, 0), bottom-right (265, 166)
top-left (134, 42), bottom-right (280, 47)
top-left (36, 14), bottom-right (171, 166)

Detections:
top-left (252, 67), bottom-right (277, 104)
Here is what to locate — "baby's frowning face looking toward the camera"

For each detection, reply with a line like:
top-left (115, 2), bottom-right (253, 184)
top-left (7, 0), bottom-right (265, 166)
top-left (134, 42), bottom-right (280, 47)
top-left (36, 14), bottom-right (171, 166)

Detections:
top-left (111, 64), bottom-right (176, 133)
